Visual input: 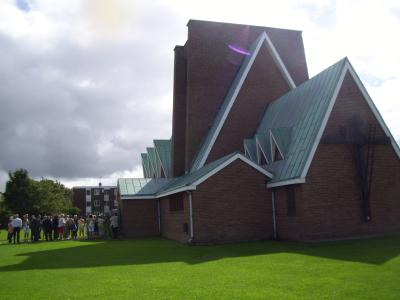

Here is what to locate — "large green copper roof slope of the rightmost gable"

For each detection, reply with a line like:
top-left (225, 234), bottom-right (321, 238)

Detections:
top-left (257, 58), bottom-right (347, 183)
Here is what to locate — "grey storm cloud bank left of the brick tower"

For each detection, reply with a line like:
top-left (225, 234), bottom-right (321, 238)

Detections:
top-left (0, 1), bottom-right (184, 186)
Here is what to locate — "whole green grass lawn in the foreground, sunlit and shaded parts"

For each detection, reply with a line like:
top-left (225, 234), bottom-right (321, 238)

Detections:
top-left (0, 231), bottom-right (400, 300)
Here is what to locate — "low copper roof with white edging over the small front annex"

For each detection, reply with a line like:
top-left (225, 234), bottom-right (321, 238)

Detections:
top-left (118, 152), bottom-right (272, 199)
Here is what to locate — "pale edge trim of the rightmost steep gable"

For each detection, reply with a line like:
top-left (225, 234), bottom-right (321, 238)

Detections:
top-left (268, 58), bottom-right (400, 188)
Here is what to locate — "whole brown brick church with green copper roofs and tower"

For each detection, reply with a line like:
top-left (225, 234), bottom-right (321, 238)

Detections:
top-left (118, 20), bottom-right (400, 244)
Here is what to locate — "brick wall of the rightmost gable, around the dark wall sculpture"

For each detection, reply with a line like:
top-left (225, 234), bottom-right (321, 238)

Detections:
top-left (276, 72), bottom-right (400, 240)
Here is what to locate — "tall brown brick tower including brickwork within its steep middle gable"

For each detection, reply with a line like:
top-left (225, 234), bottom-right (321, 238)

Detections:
top-left (171, 20), bottom-right (308, 177)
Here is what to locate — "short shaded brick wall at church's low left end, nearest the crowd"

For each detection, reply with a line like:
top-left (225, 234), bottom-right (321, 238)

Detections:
top-left (120, 199), bottom-right (159, 238)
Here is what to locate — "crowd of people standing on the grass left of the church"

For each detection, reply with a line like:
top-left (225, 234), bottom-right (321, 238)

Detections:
top-left (7, 213), bottom-right (119, 244)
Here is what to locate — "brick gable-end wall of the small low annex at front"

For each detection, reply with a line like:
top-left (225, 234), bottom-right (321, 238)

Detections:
top-left (192, 161), bottom-right (273, 244)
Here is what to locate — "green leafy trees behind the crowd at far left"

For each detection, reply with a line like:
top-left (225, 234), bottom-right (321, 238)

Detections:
top-left (0, 169), bottom-right (79, 227)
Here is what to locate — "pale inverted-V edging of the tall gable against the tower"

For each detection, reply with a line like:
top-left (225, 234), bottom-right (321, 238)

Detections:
top-left (191, 32), bottom-right (296, 171)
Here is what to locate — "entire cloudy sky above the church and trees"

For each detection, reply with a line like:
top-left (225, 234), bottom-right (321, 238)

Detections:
top-left (0, 0), bottom-right (400, 191)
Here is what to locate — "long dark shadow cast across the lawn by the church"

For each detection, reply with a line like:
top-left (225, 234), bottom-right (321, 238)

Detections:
top-left (0, 236), bottom-right (400, 272)
